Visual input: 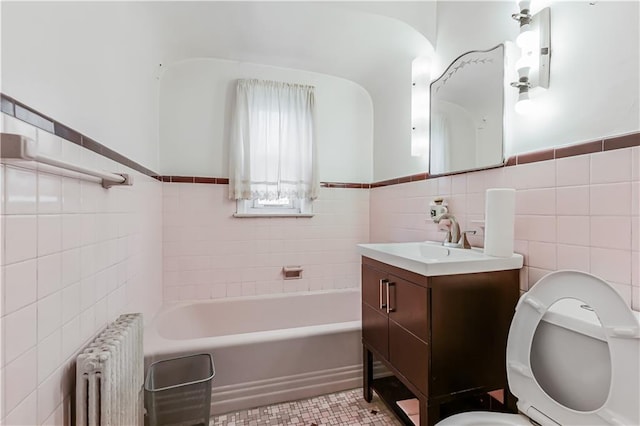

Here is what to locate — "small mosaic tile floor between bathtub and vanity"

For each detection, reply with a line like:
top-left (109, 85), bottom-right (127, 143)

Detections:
top-left (210, 389), bottom-right (401, 426)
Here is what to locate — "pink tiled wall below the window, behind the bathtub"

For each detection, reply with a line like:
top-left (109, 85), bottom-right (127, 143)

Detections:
top-left (163, 183), bottom-right (369, 301)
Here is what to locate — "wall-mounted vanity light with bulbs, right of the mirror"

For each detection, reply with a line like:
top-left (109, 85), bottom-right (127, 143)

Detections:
top-left (511, 0), bottom-right (551, 114)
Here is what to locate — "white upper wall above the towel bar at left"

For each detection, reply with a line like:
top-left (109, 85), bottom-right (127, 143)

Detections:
top-left (1, 2), bottom-right (160, 169)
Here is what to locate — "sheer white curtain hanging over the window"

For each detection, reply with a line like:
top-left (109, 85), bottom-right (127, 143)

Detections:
top-left (229, 80), bottom-right (319, 200)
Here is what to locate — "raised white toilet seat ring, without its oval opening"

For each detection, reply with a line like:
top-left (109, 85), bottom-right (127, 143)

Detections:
top-left (507, 271), bottom-right (640, 425)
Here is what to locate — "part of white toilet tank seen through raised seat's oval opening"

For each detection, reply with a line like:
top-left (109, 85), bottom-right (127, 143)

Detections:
top-left (531, 298), bottom-right (611, 412)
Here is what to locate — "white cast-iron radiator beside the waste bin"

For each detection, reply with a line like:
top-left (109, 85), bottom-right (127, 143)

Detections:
top-left (76, 314), bottom-right (144, 426)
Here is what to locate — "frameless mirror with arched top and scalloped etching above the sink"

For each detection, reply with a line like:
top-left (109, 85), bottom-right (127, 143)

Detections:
top-left (429, 44), bottom-right (504, 175)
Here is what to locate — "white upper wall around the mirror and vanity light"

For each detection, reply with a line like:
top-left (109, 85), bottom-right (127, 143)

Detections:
top-left (432, 1), bottom-right (640, 156)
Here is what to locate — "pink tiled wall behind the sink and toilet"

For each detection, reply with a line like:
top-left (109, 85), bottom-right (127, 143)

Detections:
top-left (370, 146), bottom-right (640, 310)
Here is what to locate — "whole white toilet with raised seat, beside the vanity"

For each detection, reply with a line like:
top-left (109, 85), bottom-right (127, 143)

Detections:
top-left (437, 271), bottom-right (640, 426)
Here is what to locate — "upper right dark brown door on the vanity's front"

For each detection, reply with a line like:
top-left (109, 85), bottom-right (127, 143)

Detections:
top-left (389, 275), bottom-right (429, 343)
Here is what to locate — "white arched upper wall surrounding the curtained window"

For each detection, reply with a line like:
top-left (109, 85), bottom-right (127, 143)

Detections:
top-left (160, 59), bottom-right (373, 182)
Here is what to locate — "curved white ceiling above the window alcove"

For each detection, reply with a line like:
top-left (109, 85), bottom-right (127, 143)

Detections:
top-left (146, 1), bottom-right (436, 92)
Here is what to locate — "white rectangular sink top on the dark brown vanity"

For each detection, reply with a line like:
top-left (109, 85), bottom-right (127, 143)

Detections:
top-left (358, 241), bottom-right (523, 277)
